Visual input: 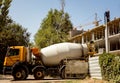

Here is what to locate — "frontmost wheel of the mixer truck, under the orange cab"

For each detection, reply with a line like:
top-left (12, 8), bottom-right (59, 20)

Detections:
top-left (13, 68), bottom-right (28, 80)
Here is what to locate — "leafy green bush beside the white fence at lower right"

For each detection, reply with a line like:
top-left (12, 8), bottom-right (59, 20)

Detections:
top-left (99, 53), bottom-right (120, 83)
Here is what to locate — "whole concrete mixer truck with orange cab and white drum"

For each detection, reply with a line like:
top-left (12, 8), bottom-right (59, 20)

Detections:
top-left (3, 43), bottom-right (93, 80)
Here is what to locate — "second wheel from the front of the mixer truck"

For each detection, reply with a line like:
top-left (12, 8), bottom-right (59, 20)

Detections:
top-left (33, 68), bottom-right (45, 80)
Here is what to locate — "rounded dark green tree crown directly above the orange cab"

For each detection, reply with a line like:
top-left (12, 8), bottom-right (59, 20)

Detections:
top-left (0, 23), bottom-right (30, 46)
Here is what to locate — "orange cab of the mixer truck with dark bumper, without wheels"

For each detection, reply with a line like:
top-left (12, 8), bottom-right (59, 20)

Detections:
top-left (3, 46), bottom-right (27, 74)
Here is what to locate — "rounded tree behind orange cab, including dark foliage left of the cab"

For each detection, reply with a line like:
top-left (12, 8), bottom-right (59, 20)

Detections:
top-left (0, 23), bottom-right (30, 73)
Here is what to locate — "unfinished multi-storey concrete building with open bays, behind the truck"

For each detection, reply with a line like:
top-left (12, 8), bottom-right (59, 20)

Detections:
top-left (69, 18), bottom-right (120, 54)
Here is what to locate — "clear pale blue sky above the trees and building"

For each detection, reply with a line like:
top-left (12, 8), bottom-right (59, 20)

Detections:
top-left (9, 0), bottom-right (120, 42)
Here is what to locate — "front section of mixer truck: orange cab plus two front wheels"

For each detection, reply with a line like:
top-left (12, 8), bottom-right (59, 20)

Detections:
top-left (3, 46), bottom-right (44, 80)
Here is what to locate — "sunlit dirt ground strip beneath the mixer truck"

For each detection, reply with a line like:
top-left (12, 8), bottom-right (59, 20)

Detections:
top-left (0, 75), bottom-right (108, 83)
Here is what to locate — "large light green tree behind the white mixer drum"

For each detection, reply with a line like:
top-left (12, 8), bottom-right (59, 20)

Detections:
top-left (34, 9), bottom-right (72, 48)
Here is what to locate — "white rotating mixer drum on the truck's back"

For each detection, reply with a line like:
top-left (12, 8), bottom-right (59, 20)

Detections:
top-left (41, 42), bottom-right (88, 66)
